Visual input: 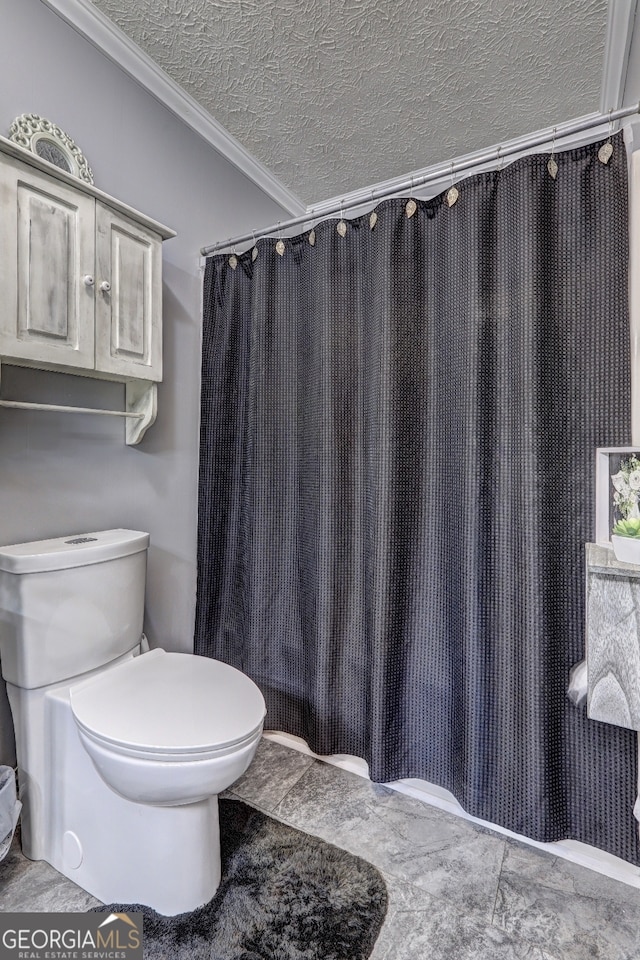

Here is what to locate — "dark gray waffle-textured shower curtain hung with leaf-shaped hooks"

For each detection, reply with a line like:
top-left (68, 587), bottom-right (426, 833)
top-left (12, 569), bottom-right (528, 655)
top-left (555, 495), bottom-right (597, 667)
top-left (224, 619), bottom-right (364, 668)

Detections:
top-left (196, 137), bottom-right (639, 862)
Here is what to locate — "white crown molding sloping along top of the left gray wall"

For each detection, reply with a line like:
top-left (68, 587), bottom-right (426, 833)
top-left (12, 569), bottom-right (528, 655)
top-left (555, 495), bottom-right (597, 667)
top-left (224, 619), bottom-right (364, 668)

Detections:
top-left (41, 0), bottom-right (306, 216)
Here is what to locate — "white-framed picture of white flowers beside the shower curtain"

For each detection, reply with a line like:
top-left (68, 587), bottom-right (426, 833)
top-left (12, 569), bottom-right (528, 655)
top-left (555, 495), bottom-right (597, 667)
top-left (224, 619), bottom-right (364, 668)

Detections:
top-left (596, 447), bottom-right (640, 545)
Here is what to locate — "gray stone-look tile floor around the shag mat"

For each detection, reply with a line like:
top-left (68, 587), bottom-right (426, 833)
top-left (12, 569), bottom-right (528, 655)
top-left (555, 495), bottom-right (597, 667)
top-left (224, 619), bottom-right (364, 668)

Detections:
top-left (0, 740), bottom-right (640, 960)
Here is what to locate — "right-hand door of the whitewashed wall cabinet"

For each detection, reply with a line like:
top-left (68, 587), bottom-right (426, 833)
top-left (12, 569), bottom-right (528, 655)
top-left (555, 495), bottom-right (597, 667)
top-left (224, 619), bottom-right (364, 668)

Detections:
top-left (96, 202), bottom-right (162, 380)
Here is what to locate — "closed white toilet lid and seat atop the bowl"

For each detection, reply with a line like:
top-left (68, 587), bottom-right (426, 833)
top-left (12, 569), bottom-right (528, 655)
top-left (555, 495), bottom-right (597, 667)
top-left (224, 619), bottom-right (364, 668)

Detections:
top-left (69, 649), bottom-right (265, 761)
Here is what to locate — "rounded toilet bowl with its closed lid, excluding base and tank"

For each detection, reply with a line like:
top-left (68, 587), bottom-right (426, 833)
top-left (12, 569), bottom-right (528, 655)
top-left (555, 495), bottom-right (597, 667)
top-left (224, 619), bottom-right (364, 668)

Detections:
top-left (69, 650), bottom-right (265, 806)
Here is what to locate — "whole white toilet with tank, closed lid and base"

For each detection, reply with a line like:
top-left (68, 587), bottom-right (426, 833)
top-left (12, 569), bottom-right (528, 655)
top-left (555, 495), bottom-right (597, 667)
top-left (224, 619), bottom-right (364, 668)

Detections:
top-left (0, 530), bottom-right (265, 914)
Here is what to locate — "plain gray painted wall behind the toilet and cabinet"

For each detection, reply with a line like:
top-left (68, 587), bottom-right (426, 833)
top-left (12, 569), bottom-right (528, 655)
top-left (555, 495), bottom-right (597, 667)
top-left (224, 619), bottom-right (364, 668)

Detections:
top-left (0, 0), bottom-right (285, 762)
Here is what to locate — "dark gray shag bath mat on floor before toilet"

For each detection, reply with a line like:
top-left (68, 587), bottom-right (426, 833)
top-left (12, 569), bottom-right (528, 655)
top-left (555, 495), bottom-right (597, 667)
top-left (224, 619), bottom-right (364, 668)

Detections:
top-left (91, 800), bottom-right (387, 960)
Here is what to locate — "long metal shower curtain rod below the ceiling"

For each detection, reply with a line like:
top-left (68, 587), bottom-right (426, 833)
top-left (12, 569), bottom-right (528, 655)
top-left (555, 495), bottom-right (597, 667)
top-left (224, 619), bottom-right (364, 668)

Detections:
top-left (200, 103), bottom-right (640, 257)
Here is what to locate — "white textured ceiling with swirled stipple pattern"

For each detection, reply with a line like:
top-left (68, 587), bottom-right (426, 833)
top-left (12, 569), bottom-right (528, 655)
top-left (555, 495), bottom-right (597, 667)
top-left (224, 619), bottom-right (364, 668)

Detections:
top-left (87, 0), bottom-right (607, 205)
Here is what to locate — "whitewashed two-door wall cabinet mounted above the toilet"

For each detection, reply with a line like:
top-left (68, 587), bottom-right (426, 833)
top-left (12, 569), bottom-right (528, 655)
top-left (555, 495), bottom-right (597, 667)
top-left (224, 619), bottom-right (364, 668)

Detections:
top-left (0, 138), bottom-right (175, 443)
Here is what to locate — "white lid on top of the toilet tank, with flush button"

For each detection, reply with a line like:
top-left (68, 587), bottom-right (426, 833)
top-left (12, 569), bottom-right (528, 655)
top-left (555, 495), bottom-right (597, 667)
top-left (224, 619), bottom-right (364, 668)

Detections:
top-left (0, 530), bottom-right (149, 573)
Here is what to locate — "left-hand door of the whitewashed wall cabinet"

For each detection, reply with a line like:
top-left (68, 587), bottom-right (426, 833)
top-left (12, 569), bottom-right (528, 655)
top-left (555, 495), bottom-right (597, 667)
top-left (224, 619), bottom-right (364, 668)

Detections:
top-left (0, 161), bottom-right (95, 370)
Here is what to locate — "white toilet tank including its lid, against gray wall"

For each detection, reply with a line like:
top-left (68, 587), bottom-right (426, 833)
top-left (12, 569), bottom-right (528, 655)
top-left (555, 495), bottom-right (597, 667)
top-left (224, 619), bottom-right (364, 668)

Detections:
top-left (0, 530), bottom-right (149, 689)
